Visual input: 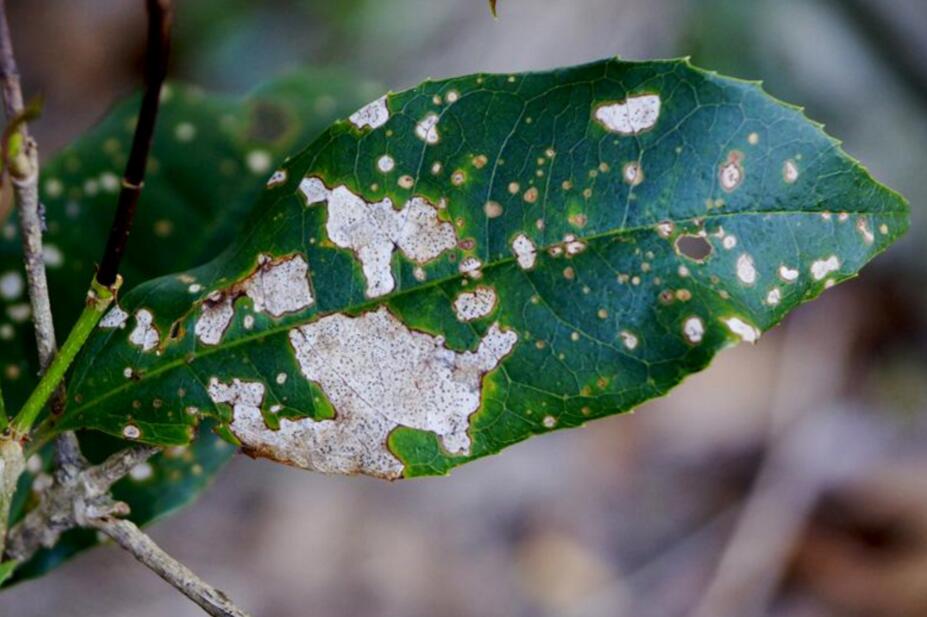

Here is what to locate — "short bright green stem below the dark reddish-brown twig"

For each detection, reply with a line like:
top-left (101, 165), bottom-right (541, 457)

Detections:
top-left (11, 279), bottom-right (121, 439)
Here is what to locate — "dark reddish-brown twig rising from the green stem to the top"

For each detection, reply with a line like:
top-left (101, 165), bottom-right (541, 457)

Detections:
top-left (97, 0), bottom-right (173, 287)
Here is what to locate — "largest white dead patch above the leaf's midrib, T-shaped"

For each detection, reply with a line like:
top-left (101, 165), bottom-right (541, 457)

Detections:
top-left (301, 178), bottom-right (457, 298)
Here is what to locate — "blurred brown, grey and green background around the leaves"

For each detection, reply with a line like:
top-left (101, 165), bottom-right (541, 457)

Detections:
top-left (0, 0), bottom-right (927, 617)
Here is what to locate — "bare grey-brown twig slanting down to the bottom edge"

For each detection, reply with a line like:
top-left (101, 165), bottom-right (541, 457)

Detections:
top-left (91, 517), bottom-right (249, 617)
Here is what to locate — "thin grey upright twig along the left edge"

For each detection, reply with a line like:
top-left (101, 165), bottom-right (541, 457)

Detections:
top-left (0, 0), bottom-right (56, 371)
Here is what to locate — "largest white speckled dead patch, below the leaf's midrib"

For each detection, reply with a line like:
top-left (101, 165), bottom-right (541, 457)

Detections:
top-left (218, 308), bottom-right (518, 478)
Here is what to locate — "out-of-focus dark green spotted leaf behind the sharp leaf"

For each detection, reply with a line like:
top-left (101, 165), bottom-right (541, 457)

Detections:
top-left (0, 71), bottom-right (376, 579)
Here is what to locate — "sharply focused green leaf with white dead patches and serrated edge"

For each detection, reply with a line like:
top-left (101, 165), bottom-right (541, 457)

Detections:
top-left (59, 60), bottom-right (908, 478)
